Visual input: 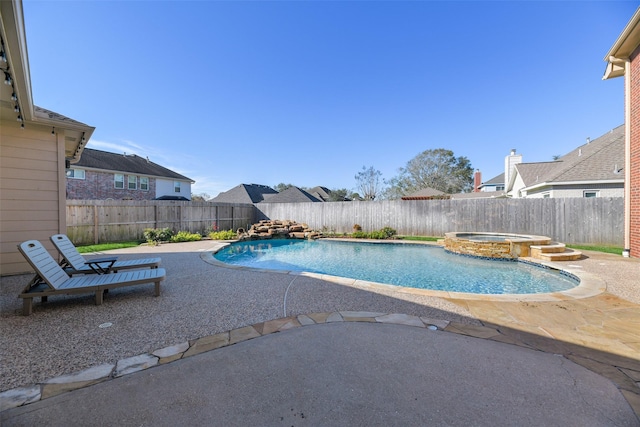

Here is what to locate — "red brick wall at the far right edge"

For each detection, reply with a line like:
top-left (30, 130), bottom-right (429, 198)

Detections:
top-left (628, 46), bottom-right (640, 258)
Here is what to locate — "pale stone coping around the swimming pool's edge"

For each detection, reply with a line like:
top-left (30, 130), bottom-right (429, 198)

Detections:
top-left (200, 238), bottom-right (607, 302)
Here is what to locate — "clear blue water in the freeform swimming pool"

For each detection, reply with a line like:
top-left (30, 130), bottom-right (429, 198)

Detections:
top-left (215, 240), bottom-right (578, 294)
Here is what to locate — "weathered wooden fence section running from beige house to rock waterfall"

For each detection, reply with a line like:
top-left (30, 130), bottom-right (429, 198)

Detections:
top-left (67, 200), bottom-right (256, 245)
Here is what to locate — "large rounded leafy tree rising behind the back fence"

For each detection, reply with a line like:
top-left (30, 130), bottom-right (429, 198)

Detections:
top-left (385, 148), bottom-right (473, 198)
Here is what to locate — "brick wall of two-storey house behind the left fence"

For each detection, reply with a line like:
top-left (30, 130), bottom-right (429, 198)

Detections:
top-left (66, 169), bottom-right (156, 200)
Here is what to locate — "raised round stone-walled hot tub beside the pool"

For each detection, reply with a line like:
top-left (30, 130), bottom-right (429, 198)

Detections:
top-left (444, 231), bottom-right (551, 259)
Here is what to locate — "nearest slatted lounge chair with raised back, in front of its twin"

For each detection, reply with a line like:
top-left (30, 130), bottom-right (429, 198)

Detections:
top-left (18, 240), bottom-right (166, 316)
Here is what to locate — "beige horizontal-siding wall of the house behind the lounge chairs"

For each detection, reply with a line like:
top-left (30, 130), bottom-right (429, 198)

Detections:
top-left (0, 121), bottom-right (66, 275)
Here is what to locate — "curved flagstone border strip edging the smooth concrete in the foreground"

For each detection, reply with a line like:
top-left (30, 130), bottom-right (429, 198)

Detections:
top-left (0, 311), bottom-right (640, 420)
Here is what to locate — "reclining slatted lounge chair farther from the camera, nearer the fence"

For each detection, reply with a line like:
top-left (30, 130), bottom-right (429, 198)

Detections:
top-left (51, 234), bottom-right (162, 275)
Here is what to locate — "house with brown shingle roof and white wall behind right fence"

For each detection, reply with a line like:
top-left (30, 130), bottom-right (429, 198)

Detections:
top-left (507, 125), bottom-right (625, 198)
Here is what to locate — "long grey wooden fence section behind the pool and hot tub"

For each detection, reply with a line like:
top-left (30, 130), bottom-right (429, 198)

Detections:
top-left (256, 197), bottom-right (624, 246)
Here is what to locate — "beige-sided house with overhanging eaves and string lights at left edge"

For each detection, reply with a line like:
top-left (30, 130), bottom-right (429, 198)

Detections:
top-left (0, 0), bottom-right (95, 275)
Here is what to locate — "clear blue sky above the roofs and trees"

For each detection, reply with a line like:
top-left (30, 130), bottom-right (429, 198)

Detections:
top-left (24, 0), bottom-right (638, 196)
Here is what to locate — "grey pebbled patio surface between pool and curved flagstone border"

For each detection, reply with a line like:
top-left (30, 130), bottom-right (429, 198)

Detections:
top-left (0, 241), bottom-right (479, 391)
